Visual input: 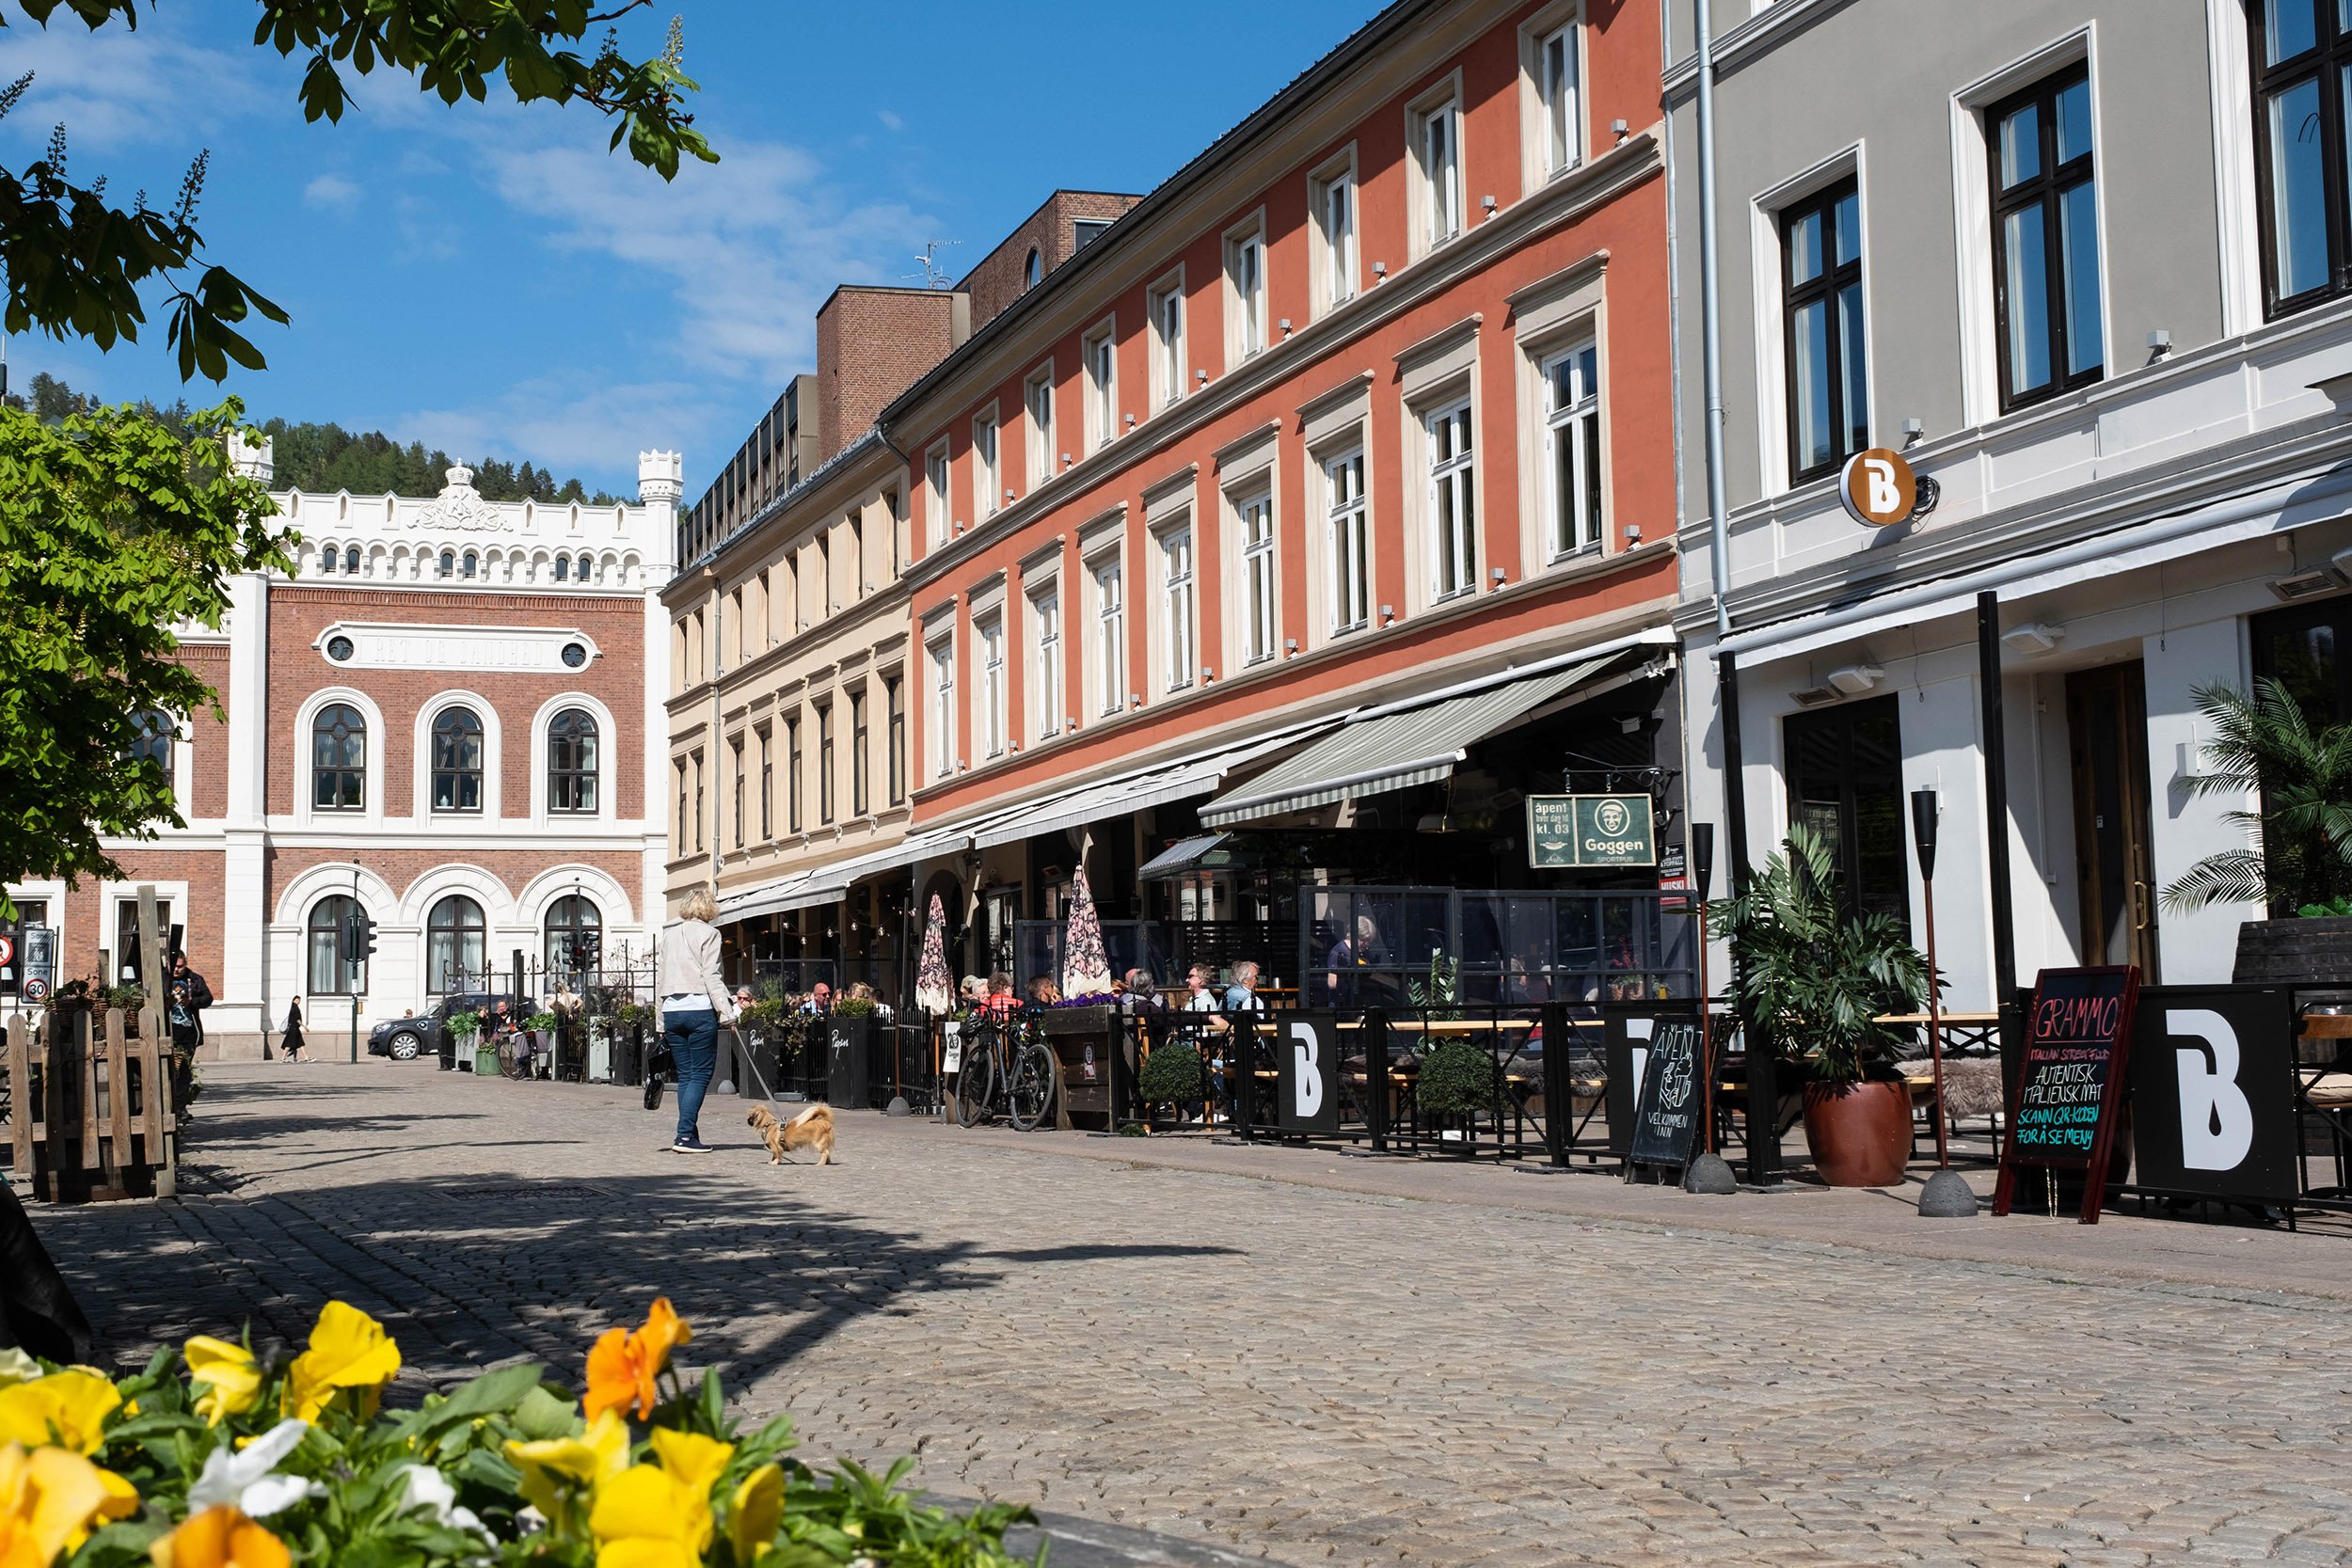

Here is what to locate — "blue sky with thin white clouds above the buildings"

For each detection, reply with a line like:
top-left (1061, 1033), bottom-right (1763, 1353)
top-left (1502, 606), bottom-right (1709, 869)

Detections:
top-left (0, 0), bottom-right (1378, 499)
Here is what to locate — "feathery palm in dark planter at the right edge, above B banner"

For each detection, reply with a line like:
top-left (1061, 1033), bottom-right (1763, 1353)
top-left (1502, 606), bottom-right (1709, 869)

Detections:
top-left (2164, 677), bottom-right (2352, 985)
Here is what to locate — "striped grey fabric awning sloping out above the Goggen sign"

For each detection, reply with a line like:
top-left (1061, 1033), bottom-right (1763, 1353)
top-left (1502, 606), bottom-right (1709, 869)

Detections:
top-left (1200, 649), bottom-right (1626, 828)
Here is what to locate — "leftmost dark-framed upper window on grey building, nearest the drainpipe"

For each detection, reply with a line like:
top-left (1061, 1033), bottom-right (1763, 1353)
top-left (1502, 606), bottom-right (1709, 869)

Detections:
top-left (1781, 179), bottom-right (1870, 484)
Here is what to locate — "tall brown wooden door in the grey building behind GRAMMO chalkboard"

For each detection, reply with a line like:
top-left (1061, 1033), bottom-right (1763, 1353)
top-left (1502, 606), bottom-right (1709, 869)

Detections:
top-left (2065, 660), bottom-right (2157, 985)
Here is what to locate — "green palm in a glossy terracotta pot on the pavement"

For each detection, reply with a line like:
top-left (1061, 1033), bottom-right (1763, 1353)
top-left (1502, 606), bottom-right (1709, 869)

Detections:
top-left (1708, 823), bottom-right (1929, 1187)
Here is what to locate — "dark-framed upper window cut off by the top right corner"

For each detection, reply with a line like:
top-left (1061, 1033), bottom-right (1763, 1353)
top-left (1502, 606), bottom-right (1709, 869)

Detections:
top-left (2247, 0), bottom-right (2352, 315)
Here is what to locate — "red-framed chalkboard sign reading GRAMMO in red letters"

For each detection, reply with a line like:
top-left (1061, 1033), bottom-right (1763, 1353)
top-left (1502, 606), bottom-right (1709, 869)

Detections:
top-left (1993, 964), bottom-right (2140, 1225)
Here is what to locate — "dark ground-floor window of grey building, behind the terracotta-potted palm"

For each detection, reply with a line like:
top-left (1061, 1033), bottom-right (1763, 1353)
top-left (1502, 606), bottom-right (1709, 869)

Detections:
top-left (1783, 696), bottom-right (1910, 931)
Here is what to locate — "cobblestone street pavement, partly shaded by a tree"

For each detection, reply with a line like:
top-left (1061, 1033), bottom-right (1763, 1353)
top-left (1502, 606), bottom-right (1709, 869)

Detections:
top-left (38, 1065), bottom-right (2352, 1568)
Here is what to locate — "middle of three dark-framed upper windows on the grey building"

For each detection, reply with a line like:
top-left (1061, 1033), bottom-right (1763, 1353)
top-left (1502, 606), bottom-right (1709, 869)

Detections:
top-left (1988, 66), bottom-right (2106, 414)
